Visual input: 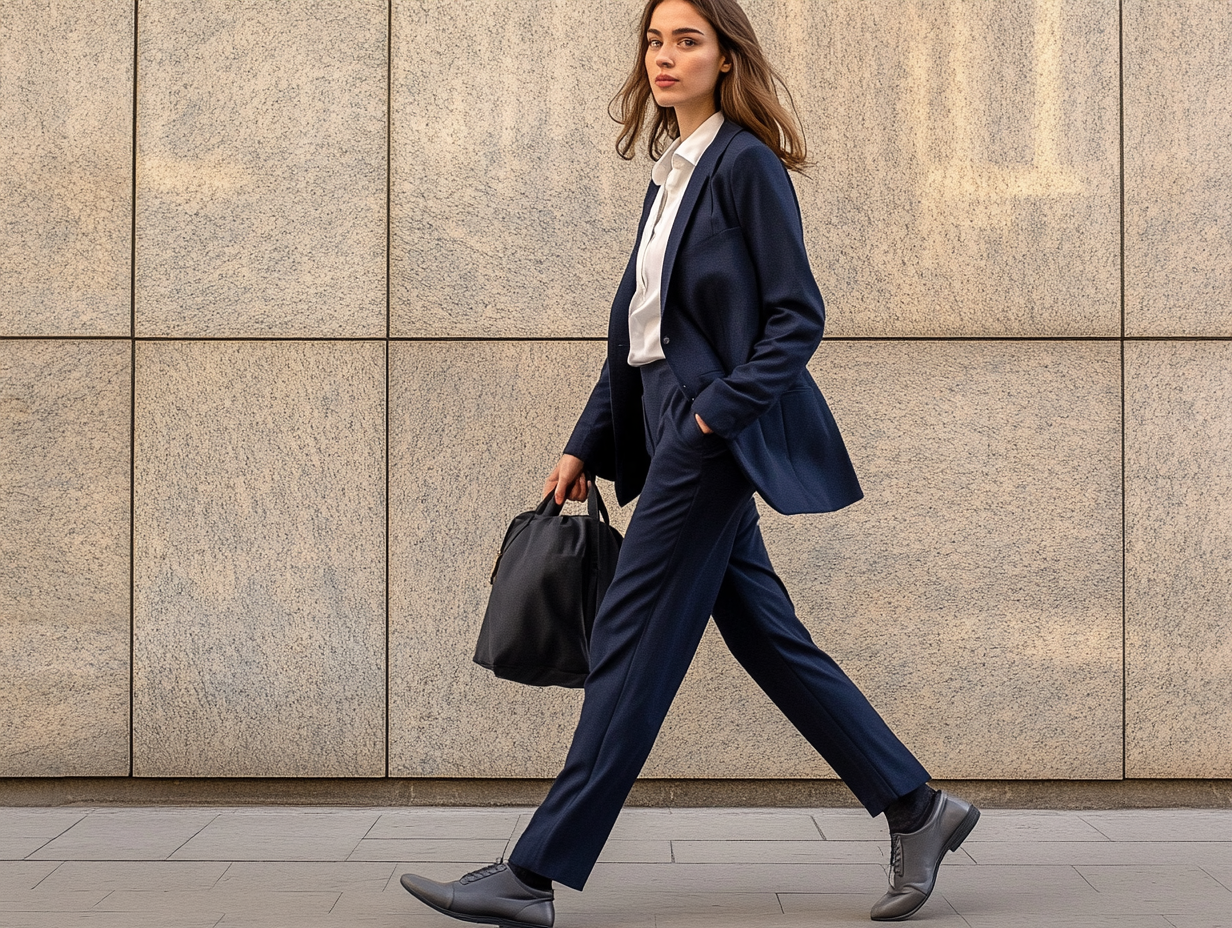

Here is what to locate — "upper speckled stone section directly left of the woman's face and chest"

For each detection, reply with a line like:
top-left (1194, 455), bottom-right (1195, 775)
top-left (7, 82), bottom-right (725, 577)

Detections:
top-left (391, 0), bottom-right (649, 338)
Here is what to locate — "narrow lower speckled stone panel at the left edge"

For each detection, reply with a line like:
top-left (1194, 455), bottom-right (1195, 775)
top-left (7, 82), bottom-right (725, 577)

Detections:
top-left (0, 340), bottom-right (131, 776)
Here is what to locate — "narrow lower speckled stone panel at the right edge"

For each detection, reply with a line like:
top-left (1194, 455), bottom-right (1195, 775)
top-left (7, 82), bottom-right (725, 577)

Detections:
top-left (1125, 341), bottom-right (1232, 778)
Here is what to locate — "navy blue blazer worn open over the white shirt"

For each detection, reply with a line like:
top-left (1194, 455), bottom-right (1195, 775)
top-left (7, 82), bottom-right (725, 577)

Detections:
top-left (565, 120), bottom-right (864, 515)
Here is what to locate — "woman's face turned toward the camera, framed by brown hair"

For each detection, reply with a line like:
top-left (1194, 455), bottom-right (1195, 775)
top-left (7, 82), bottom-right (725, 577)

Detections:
top-left (646, 0), bottom-right (732, 117)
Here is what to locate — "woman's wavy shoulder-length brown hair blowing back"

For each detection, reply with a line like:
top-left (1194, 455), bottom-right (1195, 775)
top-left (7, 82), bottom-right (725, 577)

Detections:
top-left (607, 0), bottom-right (809, 171)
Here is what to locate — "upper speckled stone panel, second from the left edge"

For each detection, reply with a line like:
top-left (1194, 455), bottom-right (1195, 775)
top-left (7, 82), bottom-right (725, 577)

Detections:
top-left (137, 0), bottom-right (388, 336)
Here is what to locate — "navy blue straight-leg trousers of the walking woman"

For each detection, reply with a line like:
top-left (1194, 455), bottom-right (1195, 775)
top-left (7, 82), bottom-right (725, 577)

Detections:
top-left (510, 361), bottom-right (929, 890)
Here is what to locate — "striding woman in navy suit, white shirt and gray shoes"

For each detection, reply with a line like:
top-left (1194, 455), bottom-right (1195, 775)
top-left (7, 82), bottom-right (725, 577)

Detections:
top-left (402, 0), bottom-right (979, 928)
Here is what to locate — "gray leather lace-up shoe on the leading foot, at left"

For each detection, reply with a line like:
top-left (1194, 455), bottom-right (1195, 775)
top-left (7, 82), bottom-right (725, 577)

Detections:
top-left (402, 863), bottom-right (556, 928)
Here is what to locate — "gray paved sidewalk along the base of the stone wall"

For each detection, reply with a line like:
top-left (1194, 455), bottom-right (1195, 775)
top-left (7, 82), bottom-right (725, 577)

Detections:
top-left (0, 807), bottom-right (1232, 928)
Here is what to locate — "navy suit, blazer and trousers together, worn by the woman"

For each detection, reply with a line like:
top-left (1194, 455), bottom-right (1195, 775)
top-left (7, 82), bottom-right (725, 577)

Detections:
top-left (510, 121), bottom-right (928, 890)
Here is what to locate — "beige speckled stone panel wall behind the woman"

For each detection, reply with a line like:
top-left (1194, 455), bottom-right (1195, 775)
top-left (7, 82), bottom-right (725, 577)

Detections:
top-left (0, 0), bottom-right (1232, 780)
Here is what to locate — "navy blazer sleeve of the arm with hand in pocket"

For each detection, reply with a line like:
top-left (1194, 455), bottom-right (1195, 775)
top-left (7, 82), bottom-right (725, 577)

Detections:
top-left (692, 144), bottom-right (825, 439)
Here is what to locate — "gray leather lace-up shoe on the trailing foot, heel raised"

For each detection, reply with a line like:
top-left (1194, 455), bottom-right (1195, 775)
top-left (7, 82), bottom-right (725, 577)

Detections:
top-left (871, 790), bottom-right (979, 922)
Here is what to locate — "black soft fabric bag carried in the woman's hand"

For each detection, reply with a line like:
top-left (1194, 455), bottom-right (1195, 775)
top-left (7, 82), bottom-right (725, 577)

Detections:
top-left (474, 484), bottom-right (622, 686)
